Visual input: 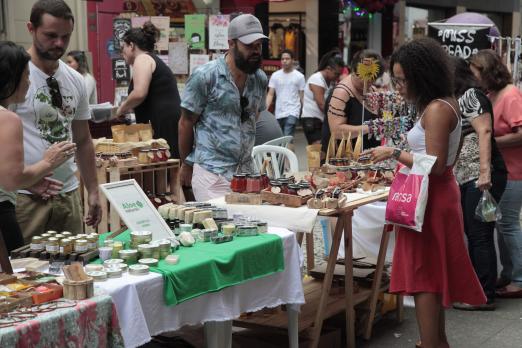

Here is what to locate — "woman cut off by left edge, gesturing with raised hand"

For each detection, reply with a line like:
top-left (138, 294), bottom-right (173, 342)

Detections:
top-left (0, 41), bottom-right (76, 251)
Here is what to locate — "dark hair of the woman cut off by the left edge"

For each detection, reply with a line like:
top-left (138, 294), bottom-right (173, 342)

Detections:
top-left (0, 41), bottom-right (31, 100)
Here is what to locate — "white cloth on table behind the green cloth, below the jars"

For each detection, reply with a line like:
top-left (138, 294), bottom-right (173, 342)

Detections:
top-left (209, 197), bottom-right (318, 233)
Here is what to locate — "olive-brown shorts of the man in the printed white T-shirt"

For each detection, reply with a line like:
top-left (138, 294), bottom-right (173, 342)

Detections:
top-left (16, 189), bottom-right (83, 243)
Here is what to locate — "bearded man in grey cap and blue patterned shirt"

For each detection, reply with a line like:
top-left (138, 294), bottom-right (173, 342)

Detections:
top-left (179, 14), bottom-right (268, 201)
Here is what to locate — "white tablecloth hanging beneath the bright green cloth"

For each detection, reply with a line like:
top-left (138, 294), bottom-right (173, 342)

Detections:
top-left (95, 227), bottom-right (304, 347)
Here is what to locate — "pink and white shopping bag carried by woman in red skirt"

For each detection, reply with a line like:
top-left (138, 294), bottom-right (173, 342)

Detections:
top-left (385, 154), bottom-right (437, 232)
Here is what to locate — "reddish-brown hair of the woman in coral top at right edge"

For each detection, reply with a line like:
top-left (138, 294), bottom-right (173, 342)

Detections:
top-left (470, 50), bottom-right (513, 92)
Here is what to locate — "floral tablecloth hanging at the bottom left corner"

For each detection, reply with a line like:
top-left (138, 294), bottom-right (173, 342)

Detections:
top-left (0, 295), bottom-right (124, 348)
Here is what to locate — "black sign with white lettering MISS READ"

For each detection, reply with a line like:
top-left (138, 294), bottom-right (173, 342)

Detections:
top-left (428, 23), bottom-right (492, 59)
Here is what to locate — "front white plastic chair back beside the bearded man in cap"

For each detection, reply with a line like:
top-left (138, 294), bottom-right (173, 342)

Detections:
top-left (252, 145), bottom-right (299, 179)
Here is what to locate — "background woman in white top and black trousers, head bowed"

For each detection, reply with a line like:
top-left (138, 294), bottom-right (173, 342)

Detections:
top-left (301, 50), bottom-right (345, 145)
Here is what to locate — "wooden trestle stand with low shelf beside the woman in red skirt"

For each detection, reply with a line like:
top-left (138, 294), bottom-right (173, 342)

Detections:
top-left (234, 192), bottom-right (402, 348)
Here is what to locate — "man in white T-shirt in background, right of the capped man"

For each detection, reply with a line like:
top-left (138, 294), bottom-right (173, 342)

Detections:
top-left (266, 50), bottom-right (305, 136)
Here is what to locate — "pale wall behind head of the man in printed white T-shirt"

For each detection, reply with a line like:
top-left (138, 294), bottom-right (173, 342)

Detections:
top-left (5, 0), bottom-right (87, 51)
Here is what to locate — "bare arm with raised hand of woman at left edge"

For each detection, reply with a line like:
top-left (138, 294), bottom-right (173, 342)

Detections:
top-left (0, 111), bottom-right (76, 191)
